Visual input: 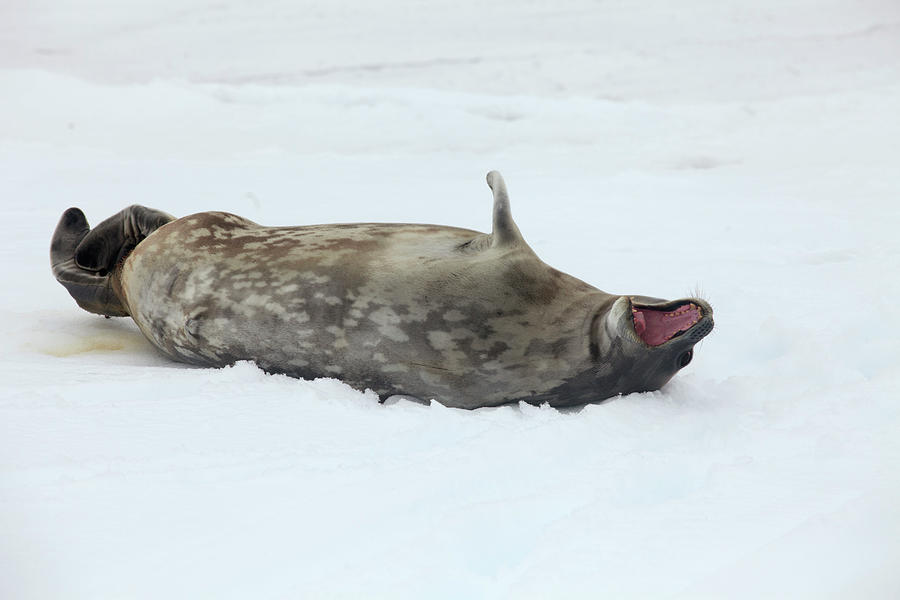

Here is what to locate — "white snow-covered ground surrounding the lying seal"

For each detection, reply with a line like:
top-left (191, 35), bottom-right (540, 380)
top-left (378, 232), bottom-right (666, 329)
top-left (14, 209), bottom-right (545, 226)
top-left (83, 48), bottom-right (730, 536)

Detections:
top-left (0, 0), bottom-right (900, 599)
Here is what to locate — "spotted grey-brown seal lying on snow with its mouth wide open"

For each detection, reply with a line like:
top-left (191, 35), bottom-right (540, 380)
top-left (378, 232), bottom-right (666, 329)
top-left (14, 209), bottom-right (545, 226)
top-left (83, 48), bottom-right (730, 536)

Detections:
top-left (50, 171), bottom-right (713, 408)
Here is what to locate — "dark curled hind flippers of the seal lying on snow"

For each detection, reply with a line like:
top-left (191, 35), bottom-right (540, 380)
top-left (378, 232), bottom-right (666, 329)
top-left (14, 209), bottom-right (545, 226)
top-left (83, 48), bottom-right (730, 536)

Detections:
top-left (50, 205), bottom-right (174, 317)
